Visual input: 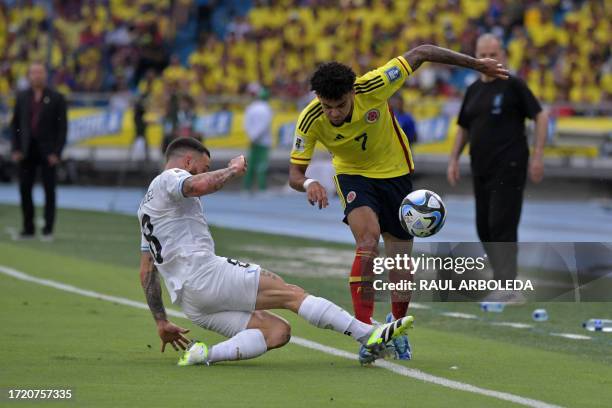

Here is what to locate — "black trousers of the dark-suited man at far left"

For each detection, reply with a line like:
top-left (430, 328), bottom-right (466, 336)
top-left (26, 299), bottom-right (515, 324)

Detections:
top-left (19, 144), bottom-right (56, 234)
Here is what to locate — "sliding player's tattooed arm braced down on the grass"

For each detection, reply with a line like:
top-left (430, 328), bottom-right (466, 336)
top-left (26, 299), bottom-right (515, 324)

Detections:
top-left (140, 252), bottom-right (189, 353)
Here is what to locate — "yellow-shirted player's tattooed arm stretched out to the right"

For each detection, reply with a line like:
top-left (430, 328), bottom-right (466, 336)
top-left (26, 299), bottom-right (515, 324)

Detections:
top-left (404, 44), bottom-right (509, 79)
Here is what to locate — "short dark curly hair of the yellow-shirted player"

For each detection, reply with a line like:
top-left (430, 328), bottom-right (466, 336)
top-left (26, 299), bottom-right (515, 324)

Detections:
top-left (310, 61), bottom-right (357, 100)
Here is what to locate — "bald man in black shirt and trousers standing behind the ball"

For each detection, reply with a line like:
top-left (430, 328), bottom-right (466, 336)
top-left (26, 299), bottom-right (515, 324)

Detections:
top-left (447, 34), bottom-right (548, 298)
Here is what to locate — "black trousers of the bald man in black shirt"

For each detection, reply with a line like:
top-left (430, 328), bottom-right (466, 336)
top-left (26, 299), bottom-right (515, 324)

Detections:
top-left (473, 162), bottom-right (527, 280)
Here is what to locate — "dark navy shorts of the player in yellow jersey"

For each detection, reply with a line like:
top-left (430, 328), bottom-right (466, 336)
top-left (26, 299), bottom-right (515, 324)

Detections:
top-left (335, 174), bottom-right (412, 240)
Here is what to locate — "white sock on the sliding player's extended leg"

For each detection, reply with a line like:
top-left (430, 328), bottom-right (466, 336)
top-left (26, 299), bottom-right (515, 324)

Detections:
top-left (298, 295), bottom-right (373, 344)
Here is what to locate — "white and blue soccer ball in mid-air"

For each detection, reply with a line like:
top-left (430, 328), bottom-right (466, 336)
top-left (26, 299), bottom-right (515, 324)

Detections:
top-left (399, 190), bottom-right (446, 238)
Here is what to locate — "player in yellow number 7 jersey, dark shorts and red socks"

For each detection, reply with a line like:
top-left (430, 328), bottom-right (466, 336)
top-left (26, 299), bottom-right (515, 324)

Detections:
top-left (289, 45), bottom-right (508, 363)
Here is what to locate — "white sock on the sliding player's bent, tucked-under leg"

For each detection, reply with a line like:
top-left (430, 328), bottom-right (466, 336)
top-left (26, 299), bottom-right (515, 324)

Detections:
top-left (208, 329), bottom-right (268, 363)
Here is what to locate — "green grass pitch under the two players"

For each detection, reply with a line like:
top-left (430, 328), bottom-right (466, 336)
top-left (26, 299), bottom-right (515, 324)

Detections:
top-left (0, 206), bottom-right (612, 407)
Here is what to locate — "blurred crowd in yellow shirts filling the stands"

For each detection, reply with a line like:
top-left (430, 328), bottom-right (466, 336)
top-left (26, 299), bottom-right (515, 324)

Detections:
top-left (0, 0), bottom-right (612, 112)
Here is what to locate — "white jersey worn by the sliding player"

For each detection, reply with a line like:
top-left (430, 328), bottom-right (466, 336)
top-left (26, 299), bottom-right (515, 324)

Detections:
top-left (138, 169), bottom-right (215, 303)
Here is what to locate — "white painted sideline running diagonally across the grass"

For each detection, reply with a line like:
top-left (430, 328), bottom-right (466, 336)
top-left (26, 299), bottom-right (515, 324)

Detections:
top-left (0, 265), bottom-right (560, 408)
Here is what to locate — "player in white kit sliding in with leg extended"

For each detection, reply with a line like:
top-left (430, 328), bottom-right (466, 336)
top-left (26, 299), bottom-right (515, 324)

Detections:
top-left (138, 138), bottom-right (413, 366)
